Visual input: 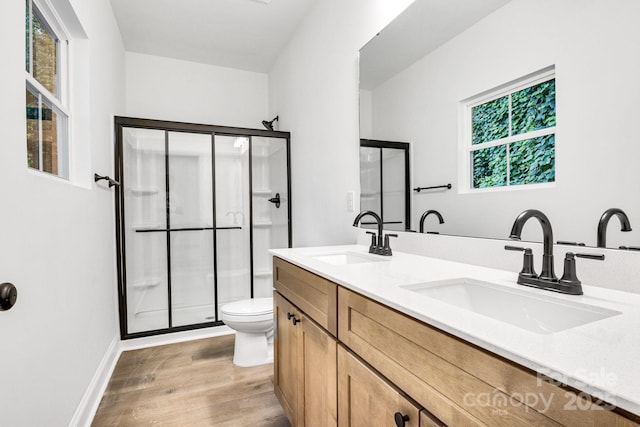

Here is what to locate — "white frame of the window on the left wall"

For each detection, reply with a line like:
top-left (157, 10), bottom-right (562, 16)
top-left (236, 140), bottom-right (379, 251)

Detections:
top-left (23, 0), bottom-right (71, 181)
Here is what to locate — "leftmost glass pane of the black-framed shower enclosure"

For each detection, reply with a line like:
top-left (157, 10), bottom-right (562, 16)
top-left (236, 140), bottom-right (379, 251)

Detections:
top-left (122, 128), bottom-right (169, 333)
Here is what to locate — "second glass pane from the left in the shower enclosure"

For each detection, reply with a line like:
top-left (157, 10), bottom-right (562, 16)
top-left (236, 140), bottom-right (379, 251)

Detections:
top-left (167, 132), bottom-right (217, 327)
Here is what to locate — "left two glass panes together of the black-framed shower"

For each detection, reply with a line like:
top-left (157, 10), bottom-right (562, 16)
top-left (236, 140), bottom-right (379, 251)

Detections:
top-left (123, 128), bottom-right (217, 334)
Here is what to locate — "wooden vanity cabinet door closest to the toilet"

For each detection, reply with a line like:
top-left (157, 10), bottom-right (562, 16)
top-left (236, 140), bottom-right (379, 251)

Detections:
top-left (273, 292), bottom-right (300, 426)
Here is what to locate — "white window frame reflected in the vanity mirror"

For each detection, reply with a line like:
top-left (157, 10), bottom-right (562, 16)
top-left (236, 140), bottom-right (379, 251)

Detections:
top-left (458, 66), bottom-right (558, 193)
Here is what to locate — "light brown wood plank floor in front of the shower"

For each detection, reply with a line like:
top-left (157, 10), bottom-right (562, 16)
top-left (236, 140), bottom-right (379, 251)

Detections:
top-left (92, 335), bottom-right (289, 427)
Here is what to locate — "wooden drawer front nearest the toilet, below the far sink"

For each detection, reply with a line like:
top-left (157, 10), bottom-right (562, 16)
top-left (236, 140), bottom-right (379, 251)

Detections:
top-left (273, 257), bottom-right (338, 336)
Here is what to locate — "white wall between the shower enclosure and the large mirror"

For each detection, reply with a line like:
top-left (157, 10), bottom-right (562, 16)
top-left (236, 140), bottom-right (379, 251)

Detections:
top-left (269, 0), bottom-right (407, 246)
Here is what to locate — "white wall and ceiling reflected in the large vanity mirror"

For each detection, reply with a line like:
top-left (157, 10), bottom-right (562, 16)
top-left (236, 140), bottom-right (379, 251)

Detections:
top-left (360, 0), bottom-right (640, 248)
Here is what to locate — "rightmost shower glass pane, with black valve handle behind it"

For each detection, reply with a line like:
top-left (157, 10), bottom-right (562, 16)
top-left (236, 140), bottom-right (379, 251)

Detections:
top-left (251, 136), bottom-right (289, 298)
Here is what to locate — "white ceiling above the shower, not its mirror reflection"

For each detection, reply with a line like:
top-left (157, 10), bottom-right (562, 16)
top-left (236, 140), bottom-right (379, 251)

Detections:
top-left (111, 0), bottom-right (316, 73)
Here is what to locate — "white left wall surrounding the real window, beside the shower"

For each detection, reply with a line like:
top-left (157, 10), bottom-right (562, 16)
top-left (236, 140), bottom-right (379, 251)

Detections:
top-left (0, 0), bottom-right (124, 426)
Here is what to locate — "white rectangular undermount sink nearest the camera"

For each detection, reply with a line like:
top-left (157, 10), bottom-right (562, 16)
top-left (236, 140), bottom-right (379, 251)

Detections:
top-left (402, 278), bottom-right (621, 334)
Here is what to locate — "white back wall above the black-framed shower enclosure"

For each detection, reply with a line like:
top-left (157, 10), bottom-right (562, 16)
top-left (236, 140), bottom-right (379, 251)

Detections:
top-left (126, 52), bottom-right (272, 128)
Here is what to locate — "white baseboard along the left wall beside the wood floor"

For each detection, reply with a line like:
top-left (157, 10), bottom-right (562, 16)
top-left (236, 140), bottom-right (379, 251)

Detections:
top-left (69, 335), bottom-right (122, 427)
